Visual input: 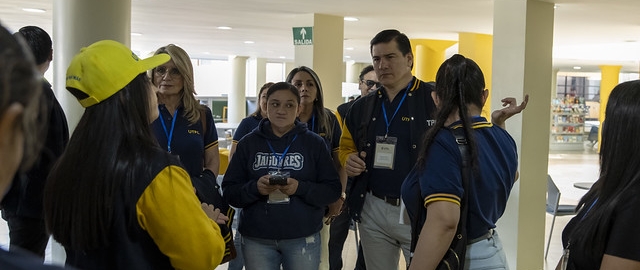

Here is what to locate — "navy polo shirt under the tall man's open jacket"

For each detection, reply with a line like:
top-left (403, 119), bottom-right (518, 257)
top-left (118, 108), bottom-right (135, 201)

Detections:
top-left (367, 89), bottom-right (413, 198)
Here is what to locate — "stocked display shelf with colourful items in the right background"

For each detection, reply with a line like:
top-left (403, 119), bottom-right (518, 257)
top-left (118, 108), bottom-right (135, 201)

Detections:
top-left (549, 100), bottom-right (589, 150)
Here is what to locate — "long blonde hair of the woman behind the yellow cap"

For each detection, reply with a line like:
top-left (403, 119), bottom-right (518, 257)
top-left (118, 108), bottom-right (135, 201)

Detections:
top-left (150, 44), bottom-right (202, 125)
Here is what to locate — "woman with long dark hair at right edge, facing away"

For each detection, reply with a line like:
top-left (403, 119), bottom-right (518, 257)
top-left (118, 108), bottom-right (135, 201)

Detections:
top-left (558, 80), bottom-right (640, 269)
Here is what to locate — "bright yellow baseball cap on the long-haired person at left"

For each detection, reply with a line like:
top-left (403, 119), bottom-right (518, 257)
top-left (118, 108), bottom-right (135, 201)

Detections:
top-left (66, 40), bottom-right (171, 108)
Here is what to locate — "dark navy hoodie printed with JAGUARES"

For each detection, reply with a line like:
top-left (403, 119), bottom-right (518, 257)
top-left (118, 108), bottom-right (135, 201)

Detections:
top-left (222, 119), bottom-right (341, 240)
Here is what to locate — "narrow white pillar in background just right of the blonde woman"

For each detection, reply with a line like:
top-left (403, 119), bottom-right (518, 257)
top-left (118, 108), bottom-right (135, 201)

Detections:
top-left (227, 56), bottom-right (249, 124)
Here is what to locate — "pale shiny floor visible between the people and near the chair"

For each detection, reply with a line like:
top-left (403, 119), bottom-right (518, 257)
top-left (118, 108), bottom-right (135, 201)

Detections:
top-left (0, 146), bottom-right (599, 269)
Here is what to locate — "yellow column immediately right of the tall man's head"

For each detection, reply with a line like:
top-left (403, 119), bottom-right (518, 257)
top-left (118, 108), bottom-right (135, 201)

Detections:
top-left (410, 39), bottom-right (457, 82)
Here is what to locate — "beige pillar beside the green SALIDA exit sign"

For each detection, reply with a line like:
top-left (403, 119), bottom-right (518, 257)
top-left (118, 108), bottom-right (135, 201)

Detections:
top-left (294, 13), bottom-right (344, 108)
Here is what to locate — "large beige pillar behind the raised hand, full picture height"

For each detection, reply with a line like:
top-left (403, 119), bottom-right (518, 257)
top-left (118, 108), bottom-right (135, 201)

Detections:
top-left (491, 0), bottom-right (554, 269)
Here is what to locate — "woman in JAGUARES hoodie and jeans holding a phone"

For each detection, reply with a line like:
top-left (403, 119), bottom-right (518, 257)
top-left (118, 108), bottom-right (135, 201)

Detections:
top-left (222, 82), bottom-right (341, 270)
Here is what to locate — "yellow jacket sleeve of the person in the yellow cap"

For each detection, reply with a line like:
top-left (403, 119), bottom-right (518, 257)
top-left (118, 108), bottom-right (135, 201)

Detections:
top-left (136, 166), bottom-right (225, 269)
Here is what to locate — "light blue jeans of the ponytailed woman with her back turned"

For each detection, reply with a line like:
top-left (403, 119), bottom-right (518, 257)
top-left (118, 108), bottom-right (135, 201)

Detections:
top-left (464, 230), bottom-right (509, 270)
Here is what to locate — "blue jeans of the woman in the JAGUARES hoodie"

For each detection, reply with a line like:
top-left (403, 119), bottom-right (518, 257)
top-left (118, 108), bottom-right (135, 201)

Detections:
top-left (242, 232), bottom-right (321, 270)
